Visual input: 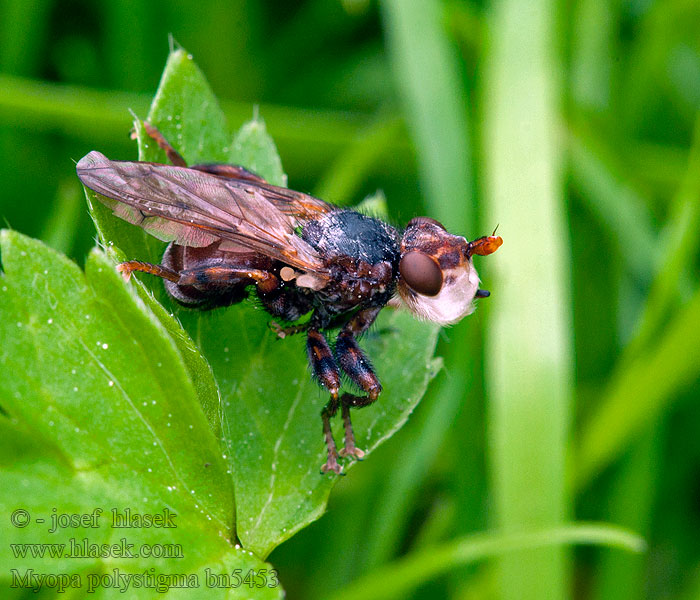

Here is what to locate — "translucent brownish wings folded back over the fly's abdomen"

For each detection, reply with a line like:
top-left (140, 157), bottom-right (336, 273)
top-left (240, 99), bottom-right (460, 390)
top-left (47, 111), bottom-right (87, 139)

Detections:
top-left (76, 151), bottom-right (333, 279)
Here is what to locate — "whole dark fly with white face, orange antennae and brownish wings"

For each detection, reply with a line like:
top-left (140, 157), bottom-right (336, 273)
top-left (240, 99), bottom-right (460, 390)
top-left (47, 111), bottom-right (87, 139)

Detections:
top-left (77, 123), bottom-right (503, 473)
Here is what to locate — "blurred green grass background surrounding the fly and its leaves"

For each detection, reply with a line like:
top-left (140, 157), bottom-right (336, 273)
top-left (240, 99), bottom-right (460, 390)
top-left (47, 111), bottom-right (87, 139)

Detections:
top-left (0, 0), bottom-right (700, 599)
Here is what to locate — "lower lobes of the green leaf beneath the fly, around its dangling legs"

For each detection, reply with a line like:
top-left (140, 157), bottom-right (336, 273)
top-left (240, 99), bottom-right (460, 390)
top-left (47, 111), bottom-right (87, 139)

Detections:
top-left (201, 306), bottom-right (440, 556)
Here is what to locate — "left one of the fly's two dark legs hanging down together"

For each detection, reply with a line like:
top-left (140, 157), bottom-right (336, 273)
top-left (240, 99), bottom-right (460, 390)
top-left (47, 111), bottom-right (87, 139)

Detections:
top-left (306, 329), bottom-right (340, 473)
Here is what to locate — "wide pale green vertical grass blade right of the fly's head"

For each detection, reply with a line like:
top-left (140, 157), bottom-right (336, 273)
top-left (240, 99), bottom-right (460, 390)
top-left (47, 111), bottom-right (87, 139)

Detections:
top-left (482, 0), bottom-right (572, 599)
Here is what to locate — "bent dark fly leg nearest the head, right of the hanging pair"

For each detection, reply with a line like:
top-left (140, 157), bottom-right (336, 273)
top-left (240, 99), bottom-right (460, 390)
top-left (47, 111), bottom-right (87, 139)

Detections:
top-left (335, 308), bottom-right (382, 459)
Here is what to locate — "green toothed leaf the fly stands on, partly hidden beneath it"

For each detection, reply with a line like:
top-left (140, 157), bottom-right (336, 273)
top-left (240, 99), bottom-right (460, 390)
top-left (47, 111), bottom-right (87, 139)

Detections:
top-left (85, 51), bottom-right (440, 557)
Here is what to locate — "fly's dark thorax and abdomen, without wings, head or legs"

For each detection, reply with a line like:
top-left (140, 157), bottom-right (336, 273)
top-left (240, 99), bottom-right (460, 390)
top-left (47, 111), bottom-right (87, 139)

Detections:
top-left (162, 209), bottom-right (400, 329)
